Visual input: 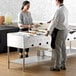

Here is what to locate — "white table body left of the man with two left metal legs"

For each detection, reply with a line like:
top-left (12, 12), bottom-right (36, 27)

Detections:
top-left (7, 32), bottom-right (51, 71)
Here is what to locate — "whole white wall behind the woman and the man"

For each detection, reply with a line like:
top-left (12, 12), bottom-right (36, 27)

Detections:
top-left (0, 0), bottom-right (76, 24)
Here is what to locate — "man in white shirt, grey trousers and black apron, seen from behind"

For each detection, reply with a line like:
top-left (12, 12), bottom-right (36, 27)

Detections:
top-left (46, 0), bottom-right (68, 71)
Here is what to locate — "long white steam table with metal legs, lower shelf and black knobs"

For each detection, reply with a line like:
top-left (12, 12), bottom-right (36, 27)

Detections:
top-left (7, 32), bottom-right (76, 71)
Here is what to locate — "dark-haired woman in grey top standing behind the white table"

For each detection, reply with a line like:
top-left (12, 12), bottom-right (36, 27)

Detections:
top-left (18, 1), bottom-right (33, 58)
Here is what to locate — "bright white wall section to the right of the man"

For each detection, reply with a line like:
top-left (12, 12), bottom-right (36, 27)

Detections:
top-left (64, 0), bottom-right (76, 26)
